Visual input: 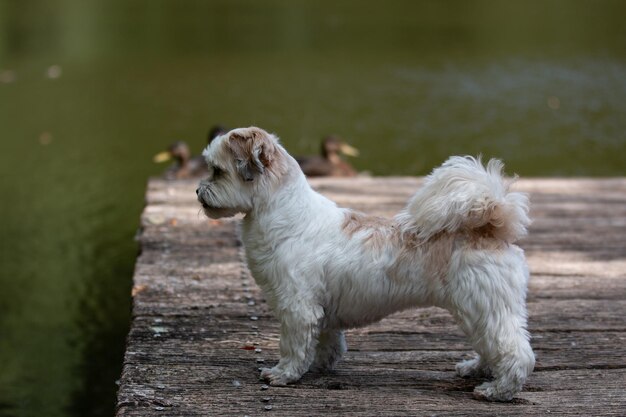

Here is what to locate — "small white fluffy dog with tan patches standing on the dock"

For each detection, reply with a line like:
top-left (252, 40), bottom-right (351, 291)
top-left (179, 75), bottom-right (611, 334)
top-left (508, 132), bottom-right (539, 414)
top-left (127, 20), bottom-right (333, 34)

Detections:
top-left (196, 127), bottom-right (535, 401)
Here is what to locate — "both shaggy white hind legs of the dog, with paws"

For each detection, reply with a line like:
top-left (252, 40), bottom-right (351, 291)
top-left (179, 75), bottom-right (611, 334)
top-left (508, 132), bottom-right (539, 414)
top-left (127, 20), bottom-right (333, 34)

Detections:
top-left (451, 256), bottom-right (535, 401)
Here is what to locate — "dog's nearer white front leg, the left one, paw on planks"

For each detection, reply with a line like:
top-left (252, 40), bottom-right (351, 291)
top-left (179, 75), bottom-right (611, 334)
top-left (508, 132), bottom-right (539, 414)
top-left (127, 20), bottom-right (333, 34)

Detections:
top-left (261, 304), bottom-right (323, 385)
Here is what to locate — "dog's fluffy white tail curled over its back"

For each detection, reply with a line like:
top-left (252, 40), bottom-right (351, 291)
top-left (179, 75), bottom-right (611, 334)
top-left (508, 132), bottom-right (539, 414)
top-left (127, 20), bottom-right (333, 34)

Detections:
top-left (397, 156), bottom-right (530, 243)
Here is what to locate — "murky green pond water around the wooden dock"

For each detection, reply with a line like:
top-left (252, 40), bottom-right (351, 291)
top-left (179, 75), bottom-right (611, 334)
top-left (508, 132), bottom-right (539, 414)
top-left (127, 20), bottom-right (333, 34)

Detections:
top-left (0, 0), bottom-right (626, 417)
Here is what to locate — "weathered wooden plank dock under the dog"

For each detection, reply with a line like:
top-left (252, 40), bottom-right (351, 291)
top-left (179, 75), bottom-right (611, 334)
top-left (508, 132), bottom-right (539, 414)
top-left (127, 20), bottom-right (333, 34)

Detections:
top-left (117, 178), bottom-right (626, 416)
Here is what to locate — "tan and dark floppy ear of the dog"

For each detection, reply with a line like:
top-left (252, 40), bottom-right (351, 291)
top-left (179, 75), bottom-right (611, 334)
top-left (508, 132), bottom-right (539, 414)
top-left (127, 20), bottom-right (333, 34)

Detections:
top-left (228, 127), bottom-right (276, 181)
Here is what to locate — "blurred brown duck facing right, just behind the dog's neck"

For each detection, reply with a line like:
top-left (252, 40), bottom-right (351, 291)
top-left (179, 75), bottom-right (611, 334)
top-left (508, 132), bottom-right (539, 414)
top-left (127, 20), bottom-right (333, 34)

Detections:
top-left (296, 135), bottom-right (359, 177)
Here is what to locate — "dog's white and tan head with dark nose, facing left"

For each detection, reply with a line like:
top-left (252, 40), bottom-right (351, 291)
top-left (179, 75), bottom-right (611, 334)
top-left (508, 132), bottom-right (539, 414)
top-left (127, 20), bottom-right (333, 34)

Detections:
top-left (196, 127), bottom-right (289, 219)
